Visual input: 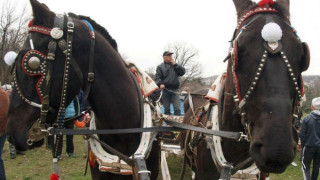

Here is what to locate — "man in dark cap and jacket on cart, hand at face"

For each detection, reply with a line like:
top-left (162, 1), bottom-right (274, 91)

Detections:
top-left (155, 51), bottom-right (186, 116)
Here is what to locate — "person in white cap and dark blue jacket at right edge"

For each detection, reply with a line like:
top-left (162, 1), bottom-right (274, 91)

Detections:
top-left (300, 97), bottom-right (320, 180)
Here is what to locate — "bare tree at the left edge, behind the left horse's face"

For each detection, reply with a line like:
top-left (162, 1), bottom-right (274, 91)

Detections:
top-left (0, 0), bottom-right (28, 83)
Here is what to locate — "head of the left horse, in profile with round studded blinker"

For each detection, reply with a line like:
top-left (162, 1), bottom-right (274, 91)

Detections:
top-left (7, 0), bottom-right (125, 153)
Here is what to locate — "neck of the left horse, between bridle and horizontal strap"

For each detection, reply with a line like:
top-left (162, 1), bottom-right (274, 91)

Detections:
top-left (89, 35), bottom-right (140, 129)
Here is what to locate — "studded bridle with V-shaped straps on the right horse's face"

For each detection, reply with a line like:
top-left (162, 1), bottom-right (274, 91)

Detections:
top-left (230, 7), bottom-right (307, 140)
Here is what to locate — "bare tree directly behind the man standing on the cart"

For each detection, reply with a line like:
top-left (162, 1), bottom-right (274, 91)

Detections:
top-left (165, 42), bottom-right (201, 87)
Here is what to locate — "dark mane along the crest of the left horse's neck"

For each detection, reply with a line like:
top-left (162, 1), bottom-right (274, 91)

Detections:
top-left (68, 13), bottom-right (118, 52)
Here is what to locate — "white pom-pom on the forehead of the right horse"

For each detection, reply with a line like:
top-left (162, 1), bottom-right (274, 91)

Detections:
top-left (261, 22), bottom-right (282, 42)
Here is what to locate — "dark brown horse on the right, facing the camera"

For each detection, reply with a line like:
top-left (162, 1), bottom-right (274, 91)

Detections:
top-left (184, 0), bottom-right (309, 180)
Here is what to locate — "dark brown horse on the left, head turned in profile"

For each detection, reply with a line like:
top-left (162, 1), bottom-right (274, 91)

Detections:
top-left (7, 0), bottom-right (160, 179)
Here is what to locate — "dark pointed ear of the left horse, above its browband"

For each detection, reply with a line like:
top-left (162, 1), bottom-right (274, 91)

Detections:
top-left (30, 0), bottom-right (54, 27)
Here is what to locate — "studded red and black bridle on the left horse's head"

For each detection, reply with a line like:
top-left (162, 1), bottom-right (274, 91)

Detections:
top-left (13, 14), bottom-right (95, 145)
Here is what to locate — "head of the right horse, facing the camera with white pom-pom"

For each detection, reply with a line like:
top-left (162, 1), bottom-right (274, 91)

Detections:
top-left (226, 0), bottom-right (309, 173)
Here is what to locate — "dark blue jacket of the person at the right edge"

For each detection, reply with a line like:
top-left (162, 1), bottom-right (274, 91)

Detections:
top-left (300, 110), bottom-right (320, 147)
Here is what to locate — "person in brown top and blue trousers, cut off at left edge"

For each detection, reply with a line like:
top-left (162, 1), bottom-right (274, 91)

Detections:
top-left (0, 88), bottom-right (9, 180)
